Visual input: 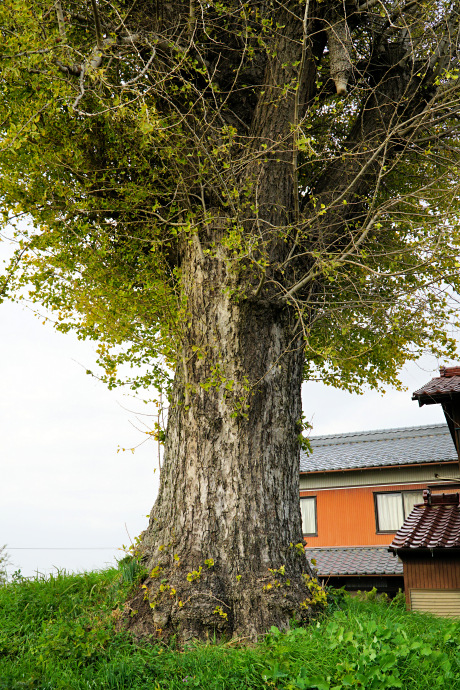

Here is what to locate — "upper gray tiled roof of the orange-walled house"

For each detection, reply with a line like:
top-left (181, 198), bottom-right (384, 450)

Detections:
top-left (300, 424), bottom-right (457, 472)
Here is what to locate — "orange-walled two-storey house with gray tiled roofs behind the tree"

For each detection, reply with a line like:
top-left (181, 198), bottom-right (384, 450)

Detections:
top-left (300, 420), bottom-right (460, 594)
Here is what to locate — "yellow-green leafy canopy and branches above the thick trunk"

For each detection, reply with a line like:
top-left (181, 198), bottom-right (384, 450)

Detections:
top-left (0, 0), bottom-right (459, 398)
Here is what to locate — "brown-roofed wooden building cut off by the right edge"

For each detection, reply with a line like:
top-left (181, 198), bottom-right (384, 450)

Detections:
top-left (389, 367), bottom-right (460, 618)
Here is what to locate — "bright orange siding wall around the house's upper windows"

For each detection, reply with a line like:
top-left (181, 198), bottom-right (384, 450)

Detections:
top-left (300, 484), bottom-right (424, 547)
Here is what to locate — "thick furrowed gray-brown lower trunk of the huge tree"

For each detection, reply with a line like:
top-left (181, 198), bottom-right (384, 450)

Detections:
top-left (129, 239), bottom-right (318, 639)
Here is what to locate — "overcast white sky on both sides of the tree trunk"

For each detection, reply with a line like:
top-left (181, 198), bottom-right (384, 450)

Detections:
top-left (0, 239), bottom-right (450, 576)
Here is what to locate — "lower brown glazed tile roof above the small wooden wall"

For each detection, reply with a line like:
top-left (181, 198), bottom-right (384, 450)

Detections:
top-left (389, 492), bottom-right (460, 551)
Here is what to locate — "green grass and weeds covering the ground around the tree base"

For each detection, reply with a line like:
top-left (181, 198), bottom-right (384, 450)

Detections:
top-left (0, 562), bottom-right (460, 690)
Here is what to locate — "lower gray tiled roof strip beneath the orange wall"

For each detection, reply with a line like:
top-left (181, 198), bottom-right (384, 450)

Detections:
top-left (305, 546), bottom-right (403, 577)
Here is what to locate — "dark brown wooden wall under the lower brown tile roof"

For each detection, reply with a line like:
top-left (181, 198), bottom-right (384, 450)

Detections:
top-left (403, 558), bottom-right (460, 608)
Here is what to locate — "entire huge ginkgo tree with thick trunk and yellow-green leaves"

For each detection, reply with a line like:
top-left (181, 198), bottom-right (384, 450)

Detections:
top-left (0, 0), bottom-right (460, 639)
